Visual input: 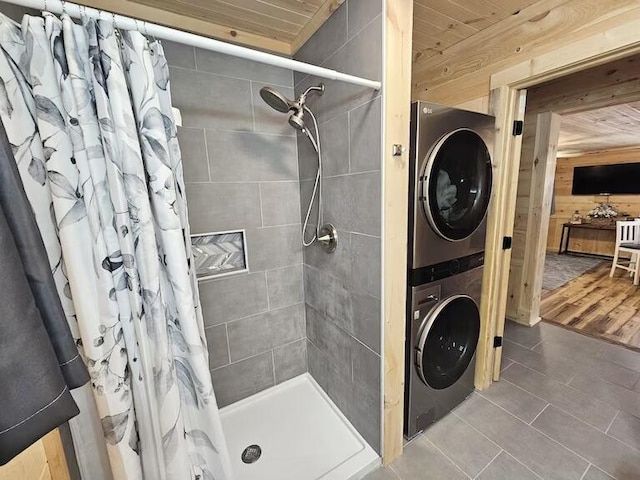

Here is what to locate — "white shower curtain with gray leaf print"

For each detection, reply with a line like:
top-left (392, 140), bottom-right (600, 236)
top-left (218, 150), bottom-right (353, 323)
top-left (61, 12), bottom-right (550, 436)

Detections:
top-left (0, 13), bottom-right (231, 480)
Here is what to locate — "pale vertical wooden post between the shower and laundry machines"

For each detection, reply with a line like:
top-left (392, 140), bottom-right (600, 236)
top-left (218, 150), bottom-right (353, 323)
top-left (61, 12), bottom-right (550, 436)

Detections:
top-left (381, 0), bottom-right (413, 465)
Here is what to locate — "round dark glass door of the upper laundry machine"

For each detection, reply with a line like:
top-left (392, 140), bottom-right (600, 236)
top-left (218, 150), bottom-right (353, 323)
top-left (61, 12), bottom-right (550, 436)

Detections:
top-left (421, 128), bottom-right (492, 241)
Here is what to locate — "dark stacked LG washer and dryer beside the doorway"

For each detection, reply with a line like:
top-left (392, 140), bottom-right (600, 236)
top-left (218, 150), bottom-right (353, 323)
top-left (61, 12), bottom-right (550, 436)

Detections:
top-left (404, 102), bottom-right (495, 438)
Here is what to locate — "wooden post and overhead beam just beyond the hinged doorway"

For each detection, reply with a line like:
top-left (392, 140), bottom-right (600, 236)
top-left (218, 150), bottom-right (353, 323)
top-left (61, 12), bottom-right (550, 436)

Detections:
top-left (506, 51), bottom-right (640, 326)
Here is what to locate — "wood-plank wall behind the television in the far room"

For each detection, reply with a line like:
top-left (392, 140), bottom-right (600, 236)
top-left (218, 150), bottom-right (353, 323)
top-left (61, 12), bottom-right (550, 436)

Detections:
top-left (547, 148), bottom-right (640, 255)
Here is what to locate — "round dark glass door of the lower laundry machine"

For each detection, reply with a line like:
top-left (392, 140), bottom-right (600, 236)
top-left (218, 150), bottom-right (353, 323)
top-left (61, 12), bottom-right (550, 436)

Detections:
top-left (415, 295), bottom-right (480, 390)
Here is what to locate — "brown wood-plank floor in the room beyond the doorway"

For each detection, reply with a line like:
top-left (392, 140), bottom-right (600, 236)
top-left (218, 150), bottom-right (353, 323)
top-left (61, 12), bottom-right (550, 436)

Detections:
top-left (541, 262), bottom-right (640, 351)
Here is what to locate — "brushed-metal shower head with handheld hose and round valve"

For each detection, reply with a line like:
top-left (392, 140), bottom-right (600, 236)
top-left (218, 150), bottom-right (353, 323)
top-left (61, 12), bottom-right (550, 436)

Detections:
top-left (260, 84), bottom-right (338, 253)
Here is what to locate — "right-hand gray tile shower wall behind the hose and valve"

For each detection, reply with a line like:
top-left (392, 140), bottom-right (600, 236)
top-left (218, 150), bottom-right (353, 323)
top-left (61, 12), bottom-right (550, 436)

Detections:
top-left (294, 0), bottom-right (383, 452)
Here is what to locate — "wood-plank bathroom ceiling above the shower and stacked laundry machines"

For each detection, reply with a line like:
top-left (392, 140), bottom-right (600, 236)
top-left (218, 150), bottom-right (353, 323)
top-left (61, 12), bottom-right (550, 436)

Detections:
top-left (80, 0), bottom-right (552, 58)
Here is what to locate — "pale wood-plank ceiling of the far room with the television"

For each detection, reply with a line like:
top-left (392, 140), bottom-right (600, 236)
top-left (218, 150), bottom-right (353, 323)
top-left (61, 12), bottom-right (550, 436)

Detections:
top-left (558, 102), bottom-right (640, 156)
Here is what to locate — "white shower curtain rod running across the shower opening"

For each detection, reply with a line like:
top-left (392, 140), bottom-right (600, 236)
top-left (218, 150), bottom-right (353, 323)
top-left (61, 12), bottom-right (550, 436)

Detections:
top-left (3, 0), bottom-right (382, 90)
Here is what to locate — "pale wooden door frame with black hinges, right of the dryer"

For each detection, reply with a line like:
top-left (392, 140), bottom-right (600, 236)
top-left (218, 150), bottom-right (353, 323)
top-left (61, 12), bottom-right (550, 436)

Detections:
top-left (476, 24), bottom-right (640, 389)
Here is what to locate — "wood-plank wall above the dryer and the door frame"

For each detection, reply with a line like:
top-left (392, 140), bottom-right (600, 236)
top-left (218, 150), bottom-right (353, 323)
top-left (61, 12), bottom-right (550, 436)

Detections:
top-left (412, 0), bottom-right (640, 106)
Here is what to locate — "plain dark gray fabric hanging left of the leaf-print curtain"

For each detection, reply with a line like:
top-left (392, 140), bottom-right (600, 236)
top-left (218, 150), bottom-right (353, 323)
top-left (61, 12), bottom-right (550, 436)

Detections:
top-left (0, 120), bottom-right (89, 465)
